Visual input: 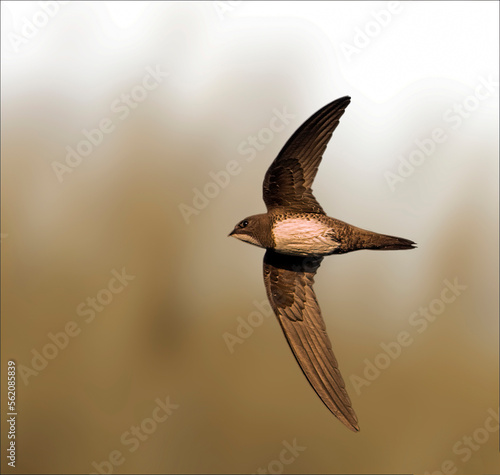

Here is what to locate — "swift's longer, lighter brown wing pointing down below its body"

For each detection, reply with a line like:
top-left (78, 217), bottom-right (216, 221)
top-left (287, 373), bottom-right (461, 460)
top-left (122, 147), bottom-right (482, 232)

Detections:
top-left (264, 250), bottom-right (359, 431)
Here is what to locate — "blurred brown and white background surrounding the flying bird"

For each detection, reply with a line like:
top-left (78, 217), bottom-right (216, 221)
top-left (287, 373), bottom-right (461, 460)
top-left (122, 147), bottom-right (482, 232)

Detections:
top-left (1, 1), bottom-right (500, 474)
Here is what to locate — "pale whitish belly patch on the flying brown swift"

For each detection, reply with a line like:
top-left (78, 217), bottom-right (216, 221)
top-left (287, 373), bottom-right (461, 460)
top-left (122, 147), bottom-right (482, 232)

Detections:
top-left (273, 218), bottom-right (339, 256)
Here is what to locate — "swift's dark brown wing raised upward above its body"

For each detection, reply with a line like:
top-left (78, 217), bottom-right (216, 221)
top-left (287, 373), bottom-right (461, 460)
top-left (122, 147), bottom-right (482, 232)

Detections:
top-left (263, 96), bottom-right (351, 214)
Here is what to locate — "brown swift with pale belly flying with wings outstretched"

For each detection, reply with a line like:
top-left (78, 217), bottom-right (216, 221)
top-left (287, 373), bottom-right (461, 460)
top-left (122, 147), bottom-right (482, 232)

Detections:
top-left (229, 96), bottom-right (415, 432)
